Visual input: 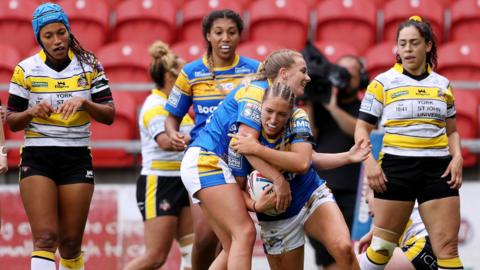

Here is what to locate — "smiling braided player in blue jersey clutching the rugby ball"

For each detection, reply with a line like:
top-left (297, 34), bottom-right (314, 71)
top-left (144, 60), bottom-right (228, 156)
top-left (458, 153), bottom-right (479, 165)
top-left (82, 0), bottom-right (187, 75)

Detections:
top-left (229, 86), bottom-right (370, 270)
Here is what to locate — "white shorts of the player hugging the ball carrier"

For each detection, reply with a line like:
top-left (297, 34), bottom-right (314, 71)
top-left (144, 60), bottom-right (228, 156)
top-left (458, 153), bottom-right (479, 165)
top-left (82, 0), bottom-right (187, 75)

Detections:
top-left (180, 147), bottom-right (236, 203)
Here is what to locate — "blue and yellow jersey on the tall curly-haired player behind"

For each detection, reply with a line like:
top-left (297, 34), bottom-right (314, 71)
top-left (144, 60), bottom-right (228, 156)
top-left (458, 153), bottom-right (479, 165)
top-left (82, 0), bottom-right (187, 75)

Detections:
top-left (165, 55), bottom-right (259, 140)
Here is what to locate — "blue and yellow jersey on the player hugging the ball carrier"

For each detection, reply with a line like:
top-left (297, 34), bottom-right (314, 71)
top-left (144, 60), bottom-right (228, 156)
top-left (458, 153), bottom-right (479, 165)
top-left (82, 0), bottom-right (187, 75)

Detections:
top-left (190, 81), bottom-right (269, 157)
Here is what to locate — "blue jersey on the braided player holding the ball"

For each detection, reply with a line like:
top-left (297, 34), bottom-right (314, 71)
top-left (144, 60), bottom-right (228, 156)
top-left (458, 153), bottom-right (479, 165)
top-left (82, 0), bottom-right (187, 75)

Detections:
top-left (228, 108), bottom-right (325, 221)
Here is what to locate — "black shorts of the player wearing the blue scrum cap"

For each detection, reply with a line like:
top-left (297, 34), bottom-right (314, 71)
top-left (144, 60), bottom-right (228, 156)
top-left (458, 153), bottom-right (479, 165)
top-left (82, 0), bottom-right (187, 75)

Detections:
top-left (19, 146), bottom-right (95, 186)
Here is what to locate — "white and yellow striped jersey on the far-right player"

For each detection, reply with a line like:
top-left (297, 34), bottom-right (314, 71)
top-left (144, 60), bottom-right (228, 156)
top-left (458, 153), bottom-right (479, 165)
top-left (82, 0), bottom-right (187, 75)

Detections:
top-left (359, 64), bottom-right (455, 157)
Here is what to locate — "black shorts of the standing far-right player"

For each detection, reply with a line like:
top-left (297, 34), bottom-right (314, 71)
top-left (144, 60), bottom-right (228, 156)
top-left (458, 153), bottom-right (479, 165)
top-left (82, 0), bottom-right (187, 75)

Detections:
top-left (374, 154), bottom-right (458, 204)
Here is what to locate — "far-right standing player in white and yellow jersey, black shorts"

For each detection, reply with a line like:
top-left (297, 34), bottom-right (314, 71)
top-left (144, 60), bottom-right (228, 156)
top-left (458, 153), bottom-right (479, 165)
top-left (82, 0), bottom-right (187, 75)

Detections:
top-left (355, 16), bottom-right (463, 270)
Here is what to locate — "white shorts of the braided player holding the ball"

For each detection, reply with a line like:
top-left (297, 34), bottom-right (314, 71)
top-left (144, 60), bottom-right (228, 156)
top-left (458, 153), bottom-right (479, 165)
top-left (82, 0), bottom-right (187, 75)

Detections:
top-left (259, 184), bottom-right (335, 255)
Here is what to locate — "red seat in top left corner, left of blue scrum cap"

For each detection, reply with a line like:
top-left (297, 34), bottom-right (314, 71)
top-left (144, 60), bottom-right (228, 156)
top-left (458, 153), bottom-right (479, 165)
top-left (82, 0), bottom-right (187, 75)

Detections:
top-left (0, 0), bottom-right (37, 55)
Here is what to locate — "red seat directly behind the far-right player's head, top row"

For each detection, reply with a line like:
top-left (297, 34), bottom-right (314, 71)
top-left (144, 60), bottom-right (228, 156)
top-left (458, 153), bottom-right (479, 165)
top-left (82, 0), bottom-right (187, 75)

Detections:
top-left (383, 0), bottom-right (444, 42)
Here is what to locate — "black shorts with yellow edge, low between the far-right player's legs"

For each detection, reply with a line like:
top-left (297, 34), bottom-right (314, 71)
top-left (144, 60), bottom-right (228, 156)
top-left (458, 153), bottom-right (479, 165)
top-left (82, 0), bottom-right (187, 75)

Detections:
top-left (402, 236), bottom-right (438, 270)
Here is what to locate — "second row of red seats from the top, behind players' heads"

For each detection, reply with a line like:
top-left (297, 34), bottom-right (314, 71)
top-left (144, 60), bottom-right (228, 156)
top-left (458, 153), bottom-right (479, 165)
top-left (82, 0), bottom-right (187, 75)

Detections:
top-left (0, 41), bottom-right (480, 85)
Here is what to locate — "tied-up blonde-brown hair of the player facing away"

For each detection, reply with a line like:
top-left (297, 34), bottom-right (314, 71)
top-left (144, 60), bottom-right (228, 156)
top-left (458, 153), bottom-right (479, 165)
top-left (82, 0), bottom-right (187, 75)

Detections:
top-left (148, 40), bottom-right (179, 88)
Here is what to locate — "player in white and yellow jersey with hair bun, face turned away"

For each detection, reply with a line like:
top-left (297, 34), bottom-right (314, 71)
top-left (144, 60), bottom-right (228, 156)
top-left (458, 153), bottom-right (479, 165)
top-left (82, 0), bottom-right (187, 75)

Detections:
top-left (125, 41), bottom-right (193, 270)
